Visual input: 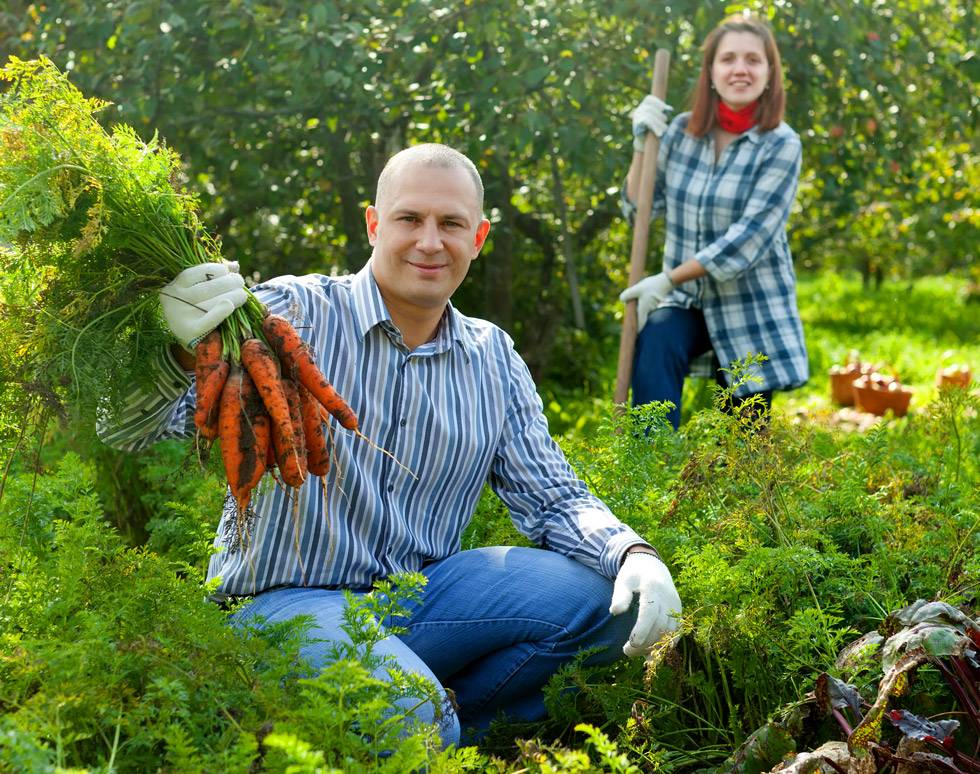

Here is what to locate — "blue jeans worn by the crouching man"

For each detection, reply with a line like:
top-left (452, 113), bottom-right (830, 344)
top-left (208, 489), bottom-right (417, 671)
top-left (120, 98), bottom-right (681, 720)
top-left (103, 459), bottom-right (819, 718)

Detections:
top-left (239, 546), bottom-right (636, 746)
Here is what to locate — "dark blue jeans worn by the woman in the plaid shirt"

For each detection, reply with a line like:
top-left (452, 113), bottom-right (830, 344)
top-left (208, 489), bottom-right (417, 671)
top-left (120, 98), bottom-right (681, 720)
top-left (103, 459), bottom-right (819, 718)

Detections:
top-left (633, 306), bottom-right (772, 430)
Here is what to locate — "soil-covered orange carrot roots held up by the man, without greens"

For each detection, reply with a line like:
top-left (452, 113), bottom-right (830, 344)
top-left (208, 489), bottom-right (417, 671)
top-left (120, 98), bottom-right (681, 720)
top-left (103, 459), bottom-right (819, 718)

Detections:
top-left (194, 314), bottom-right (359, 520)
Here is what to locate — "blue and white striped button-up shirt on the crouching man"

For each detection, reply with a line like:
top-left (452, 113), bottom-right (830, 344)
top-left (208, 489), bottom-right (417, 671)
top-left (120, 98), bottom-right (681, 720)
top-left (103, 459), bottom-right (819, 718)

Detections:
top-left (102, 264), bottom-right (644, 595)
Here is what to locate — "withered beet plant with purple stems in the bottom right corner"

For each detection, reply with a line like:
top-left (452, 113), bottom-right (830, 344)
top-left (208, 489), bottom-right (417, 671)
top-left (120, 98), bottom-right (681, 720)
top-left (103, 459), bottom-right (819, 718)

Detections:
top-left (720, 600), bottom-right (980, 772)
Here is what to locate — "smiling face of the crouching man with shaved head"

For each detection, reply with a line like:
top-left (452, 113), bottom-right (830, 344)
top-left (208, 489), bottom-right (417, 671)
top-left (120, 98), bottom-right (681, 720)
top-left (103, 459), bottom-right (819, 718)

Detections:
top-left (365, 163), bottom-right (490, 317)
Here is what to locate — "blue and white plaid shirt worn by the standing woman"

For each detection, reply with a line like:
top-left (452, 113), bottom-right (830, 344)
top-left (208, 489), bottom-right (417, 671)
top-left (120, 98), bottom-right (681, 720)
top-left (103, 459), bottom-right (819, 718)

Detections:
top-left (622, 113), bottom-right (809, 395)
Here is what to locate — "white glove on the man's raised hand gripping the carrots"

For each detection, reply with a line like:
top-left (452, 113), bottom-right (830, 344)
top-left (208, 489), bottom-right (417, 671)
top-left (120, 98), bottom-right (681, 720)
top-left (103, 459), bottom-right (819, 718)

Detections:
top-left (160, 261), bottom-right (248, 349)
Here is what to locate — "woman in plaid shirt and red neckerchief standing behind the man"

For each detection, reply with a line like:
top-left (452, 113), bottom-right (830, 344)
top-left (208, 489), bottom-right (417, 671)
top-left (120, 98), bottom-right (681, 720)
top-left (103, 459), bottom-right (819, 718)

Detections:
top-left (620, 16), bottom-right (808, 429)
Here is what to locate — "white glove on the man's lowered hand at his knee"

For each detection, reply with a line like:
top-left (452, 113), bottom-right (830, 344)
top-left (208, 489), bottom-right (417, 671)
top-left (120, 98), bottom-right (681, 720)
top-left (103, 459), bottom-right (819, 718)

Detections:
top-left (609, 552), bottom-right (681, 656)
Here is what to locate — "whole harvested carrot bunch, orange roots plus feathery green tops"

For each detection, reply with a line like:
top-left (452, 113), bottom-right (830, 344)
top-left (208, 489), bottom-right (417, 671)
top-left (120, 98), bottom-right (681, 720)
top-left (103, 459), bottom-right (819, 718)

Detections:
top-left (0, 57), bottom-right (357, 520)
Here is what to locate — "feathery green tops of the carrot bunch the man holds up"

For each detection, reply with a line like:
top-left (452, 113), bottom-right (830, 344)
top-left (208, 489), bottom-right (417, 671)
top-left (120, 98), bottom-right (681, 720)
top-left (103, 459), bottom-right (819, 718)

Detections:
top-left (0, 57), bottom-right (264, 428)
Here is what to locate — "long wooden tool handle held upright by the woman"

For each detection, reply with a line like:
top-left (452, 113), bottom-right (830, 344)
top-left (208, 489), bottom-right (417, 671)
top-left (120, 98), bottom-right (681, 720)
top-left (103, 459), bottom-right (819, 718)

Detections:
top-left (613, 48), bottom-right (670, 410)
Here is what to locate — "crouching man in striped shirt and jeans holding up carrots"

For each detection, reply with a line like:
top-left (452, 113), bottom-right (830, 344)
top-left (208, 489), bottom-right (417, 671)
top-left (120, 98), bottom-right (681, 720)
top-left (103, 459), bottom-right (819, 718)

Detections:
top-left (101, 145), bottom-right (681, 744)
